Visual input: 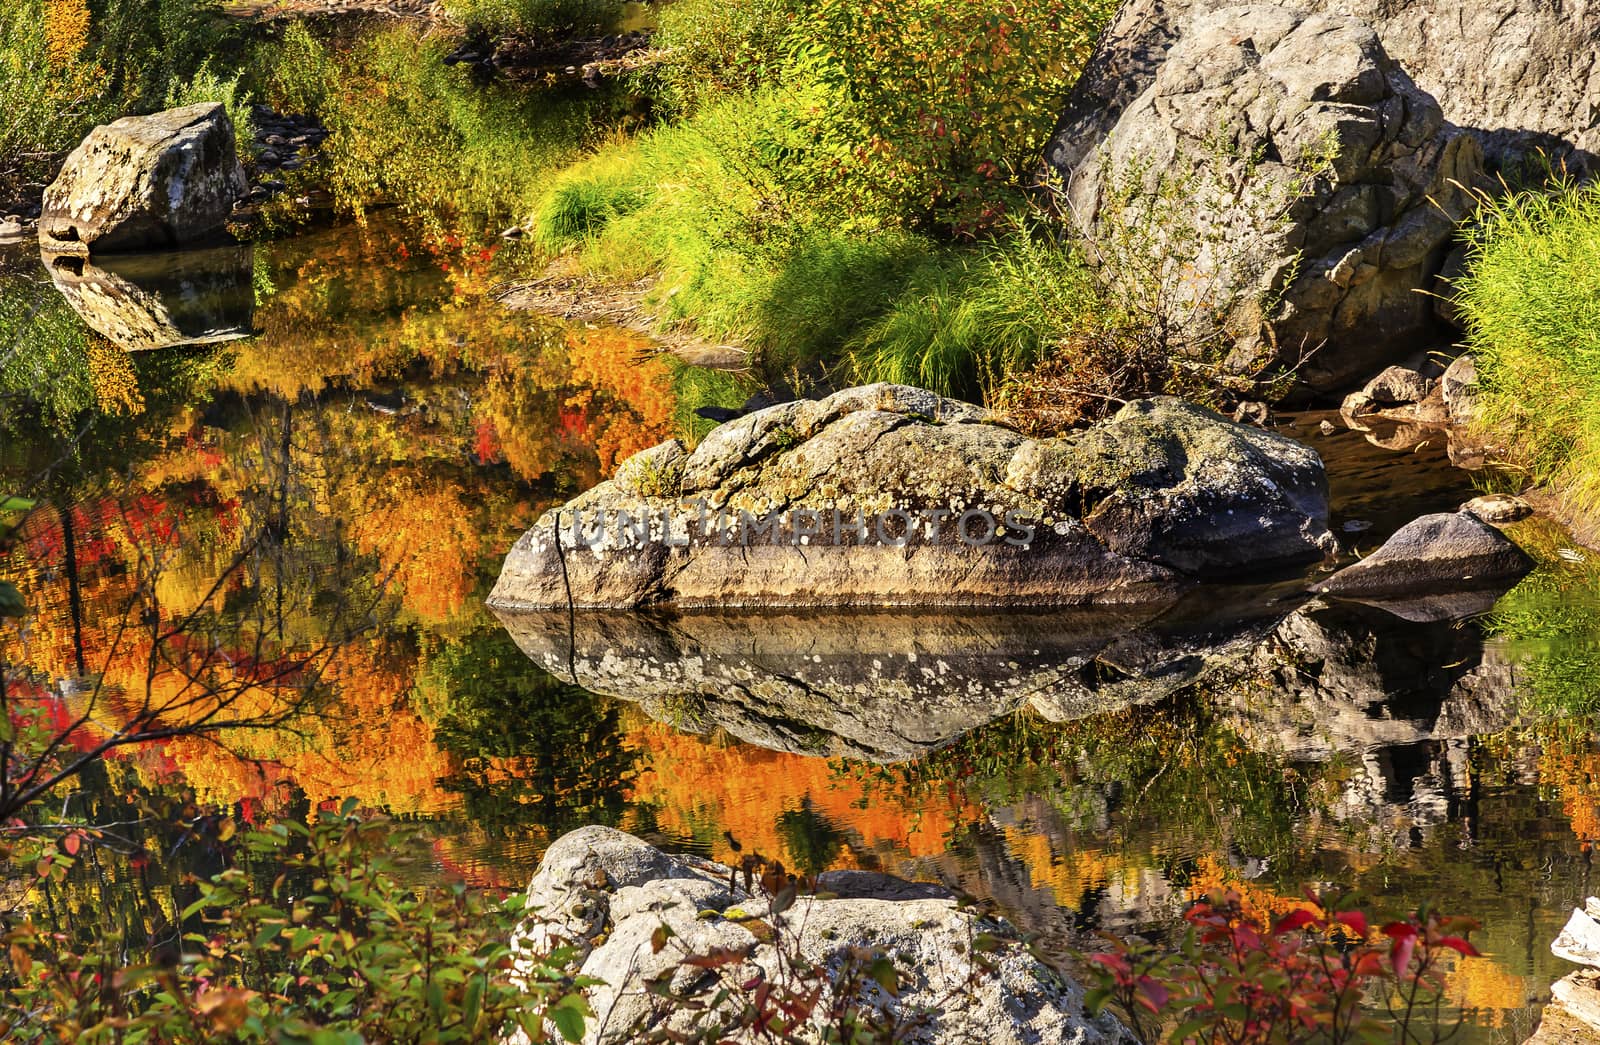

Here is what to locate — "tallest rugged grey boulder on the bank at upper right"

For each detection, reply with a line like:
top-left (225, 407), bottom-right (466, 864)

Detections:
top-left (1062, 5), bottom-right (1482, 390)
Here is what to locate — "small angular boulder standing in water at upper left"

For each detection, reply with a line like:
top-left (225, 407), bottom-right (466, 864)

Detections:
top-left (38, 104), bottom-right (250, 253)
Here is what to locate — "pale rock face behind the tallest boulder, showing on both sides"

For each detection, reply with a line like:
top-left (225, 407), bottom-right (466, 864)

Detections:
top-left (1046, 0), bottom-right (1600, 174)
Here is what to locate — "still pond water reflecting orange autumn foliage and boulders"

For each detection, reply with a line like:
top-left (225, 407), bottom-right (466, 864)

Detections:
top-left (0, 218), bottom-right (1600, 1042)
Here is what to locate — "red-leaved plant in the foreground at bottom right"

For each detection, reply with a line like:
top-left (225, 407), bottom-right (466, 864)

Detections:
top-left (1086, 890), bottom-right (1478, 1045)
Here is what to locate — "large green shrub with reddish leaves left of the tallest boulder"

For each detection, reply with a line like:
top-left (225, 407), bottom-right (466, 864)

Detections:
top-left (787, 0), bottom-right (1117, 234)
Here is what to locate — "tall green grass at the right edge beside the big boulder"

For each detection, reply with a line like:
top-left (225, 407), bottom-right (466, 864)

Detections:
top-left (1456, 184), bottom-right (1600, 512)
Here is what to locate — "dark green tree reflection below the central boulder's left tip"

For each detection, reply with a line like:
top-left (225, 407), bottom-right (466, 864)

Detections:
top-left (418, 627), bottom-right (638, 837)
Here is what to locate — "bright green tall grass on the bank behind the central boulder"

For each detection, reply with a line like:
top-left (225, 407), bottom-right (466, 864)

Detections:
top-left (534, 94), bottom-right (1099, 397)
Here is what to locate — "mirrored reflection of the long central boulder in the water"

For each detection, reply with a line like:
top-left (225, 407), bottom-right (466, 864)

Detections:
top-left (501, 599), bottom-right (1282, 762)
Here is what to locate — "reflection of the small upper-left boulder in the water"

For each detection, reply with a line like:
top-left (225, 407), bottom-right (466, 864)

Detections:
top-left (43, 243), bottom-right (254, 350)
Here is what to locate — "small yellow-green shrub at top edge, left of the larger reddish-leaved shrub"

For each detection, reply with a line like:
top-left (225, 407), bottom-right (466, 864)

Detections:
top-left (650, 0), bottom-right (802, 115)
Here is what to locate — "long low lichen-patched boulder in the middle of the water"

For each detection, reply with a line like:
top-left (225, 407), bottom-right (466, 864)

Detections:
top-left (490, 384), bottom-right (1331, 610)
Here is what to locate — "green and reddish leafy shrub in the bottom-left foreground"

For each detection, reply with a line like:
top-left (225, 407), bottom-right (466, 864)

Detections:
top-left (0, 802), bottom-right (601, 1043)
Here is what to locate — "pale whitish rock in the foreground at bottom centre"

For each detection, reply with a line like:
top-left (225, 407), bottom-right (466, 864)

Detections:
top-left (515, 827), bottom-right (1131, 1045)
